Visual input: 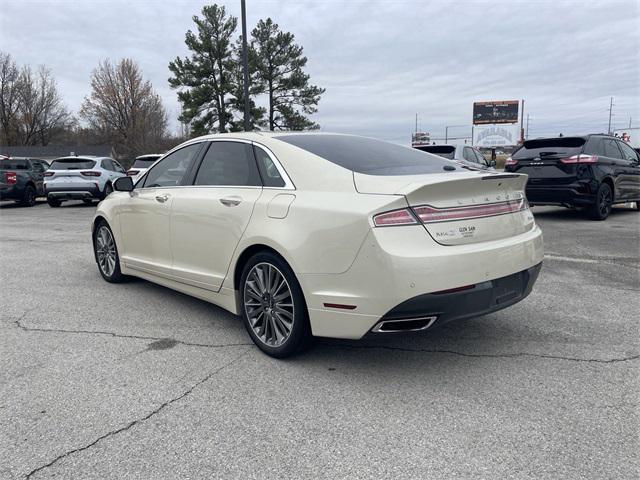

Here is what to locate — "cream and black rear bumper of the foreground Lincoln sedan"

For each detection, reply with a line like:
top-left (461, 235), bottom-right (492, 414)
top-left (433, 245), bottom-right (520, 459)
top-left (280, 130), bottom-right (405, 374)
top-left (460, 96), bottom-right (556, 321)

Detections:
top-left (298, 226), bottom-right (543, 339)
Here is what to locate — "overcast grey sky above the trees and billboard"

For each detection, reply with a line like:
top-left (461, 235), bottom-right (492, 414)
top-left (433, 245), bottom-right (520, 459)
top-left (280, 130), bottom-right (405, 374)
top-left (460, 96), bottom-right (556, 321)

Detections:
top-left (0, 0), bottom-right (640, 143)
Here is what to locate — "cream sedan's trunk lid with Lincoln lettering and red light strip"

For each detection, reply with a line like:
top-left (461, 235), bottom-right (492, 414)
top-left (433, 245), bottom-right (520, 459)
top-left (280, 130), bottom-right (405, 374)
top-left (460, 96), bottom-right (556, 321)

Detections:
top-left (354, 172), bottom-right (534, 245)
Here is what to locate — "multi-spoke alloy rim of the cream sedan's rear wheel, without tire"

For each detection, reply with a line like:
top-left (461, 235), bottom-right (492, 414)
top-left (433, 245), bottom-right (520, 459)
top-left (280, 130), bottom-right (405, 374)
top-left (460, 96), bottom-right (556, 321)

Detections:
top-left (243, 262), bottom-right (294, 347)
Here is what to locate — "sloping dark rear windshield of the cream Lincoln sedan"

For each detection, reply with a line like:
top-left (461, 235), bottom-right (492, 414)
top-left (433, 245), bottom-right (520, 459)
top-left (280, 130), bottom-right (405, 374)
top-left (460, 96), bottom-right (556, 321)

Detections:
top-left (276, 134), bottom-right (459, 175)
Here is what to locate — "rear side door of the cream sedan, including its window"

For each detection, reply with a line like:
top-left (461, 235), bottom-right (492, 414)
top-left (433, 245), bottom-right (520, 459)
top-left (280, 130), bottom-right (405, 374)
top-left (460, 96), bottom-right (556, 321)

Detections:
top-left (171, 140), bottom-right (262, 292)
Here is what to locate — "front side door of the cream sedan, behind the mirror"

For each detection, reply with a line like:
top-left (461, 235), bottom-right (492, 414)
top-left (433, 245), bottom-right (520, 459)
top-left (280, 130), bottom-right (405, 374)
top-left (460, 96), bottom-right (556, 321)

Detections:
top-left (117, 142), bottom-right (203, 276)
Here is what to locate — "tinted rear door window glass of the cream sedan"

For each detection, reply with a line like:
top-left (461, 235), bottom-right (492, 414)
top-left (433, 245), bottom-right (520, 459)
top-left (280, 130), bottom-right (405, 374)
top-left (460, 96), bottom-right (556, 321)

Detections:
top-left (194, 142), bottom-right (262, 186)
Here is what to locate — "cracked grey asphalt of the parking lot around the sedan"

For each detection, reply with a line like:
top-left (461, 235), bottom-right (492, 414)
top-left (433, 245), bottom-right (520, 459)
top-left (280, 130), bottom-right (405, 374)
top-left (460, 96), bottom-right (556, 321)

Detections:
top-left (0, 203), bottom-right (640, 479)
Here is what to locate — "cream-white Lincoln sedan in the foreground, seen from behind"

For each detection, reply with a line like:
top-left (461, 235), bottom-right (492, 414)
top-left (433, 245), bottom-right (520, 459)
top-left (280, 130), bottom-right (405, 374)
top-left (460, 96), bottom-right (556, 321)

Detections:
top-left (92, 132), bottom-right (543, 357)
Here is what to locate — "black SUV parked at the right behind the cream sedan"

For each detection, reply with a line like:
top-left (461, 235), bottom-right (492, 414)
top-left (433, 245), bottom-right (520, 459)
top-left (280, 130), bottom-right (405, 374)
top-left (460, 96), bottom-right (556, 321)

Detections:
top-left (505, 134), bottom-right (640, 220)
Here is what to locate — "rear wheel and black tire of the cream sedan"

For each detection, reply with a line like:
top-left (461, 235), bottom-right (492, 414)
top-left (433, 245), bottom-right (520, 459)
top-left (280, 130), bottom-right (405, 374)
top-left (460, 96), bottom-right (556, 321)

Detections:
top-left (240, 252), bottom-right (312, 358)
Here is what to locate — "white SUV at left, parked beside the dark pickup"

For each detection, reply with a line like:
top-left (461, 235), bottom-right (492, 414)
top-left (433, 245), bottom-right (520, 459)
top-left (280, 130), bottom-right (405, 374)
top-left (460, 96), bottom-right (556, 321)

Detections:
top-left (44, 156), bottom-right (125, 207)
